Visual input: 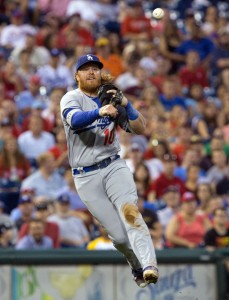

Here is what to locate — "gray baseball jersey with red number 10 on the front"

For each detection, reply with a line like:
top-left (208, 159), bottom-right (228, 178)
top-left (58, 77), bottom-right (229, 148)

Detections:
top-left (60, 89), bottom-right (120, 168)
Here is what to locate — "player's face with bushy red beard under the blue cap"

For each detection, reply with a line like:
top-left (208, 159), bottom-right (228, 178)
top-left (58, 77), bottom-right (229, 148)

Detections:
top-left (76, 63), bottom-right (101, 93)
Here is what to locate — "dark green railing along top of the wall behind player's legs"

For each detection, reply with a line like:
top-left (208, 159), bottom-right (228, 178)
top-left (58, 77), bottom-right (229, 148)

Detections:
top-left (0, 248), bottom-right (229, 300)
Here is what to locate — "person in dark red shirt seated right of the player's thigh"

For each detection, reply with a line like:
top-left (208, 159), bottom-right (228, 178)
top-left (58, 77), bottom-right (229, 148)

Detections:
top-left (148, 153), bottom-right (185, 201)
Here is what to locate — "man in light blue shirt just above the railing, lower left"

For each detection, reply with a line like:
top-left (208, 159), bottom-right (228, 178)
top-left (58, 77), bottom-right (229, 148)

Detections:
top-left (15, 218), bottom-right (53, 250)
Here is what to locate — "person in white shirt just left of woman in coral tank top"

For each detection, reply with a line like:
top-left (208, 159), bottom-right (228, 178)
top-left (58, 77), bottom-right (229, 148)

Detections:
top-left (157, 185), bottom-right (180, 234)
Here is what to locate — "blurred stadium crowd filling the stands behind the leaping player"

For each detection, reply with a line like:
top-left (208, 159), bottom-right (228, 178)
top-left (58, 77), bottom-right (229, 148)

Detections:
top-left (0, 0), bottom-right (229, 276)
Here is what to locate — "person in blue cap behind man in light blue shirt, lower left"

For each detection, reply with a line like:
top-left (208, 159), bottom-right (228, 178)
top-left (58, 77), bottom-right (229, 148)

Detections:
top-left (11, 195), bottom-right (33, 231)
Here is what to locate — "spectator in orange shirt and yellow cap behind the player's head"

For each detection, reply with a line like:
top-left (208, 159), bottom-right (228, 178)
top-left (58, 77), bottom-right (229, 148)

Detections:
top-left (95, 36), bottom-right (124, 78)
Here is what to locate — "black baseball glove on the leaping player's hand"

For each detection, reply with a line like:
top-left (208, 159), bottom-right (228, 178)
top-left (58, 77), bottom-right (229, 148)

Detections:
top-left (98, 83), bottom-right (133, 132)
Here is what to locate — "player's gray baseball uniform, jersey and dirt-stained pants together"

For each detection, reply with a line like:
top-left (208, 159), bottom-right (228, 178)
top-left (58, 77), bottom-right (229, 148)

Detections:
top-left (60, 89), bottom-right (156, 269)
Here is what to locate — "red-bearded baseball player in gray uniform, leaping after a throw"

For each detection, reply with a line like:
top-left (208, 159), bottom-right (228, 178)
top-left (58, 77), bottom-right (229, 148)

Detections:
top-left (60, 54), bottom-right (158, 287)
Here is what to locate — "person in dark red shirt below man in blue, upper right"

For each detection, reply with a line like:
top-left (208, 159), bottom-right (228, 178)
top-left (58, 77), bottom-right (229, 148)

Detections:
top-left (179, 50), bottom-right (209, 88)
